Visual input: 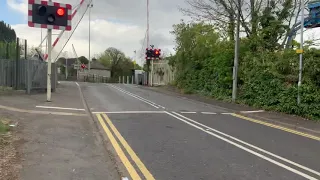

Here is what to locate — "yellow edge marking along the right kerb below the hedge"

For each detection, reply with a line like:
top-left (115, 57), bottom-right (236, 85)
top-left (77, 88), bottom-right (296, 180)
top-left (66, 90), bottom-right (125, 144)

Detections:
top-left (231, 114), bottom-right (320, 141)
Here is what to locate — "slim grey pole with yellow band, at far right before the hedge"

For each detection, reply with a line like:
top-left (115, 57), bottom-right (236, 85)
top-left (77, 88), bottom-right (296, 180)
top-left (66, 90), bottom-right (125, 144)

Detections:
top-left (297, 0), bottom-right (304, 105)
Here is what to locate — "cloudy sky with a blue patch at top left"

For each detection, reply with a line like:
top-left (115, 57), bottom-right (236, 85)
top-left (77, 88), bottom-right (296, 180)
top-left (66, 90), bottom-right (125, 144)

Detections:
top-left (0, 0), bottom-right (319, 65)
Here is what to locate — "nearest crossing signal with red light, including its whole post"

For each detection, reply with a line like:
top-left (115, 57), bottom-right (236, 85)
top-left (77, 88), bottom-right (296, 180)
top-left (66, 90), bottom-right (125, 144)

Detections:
top-left (28, 0), bottom-right (72, 102)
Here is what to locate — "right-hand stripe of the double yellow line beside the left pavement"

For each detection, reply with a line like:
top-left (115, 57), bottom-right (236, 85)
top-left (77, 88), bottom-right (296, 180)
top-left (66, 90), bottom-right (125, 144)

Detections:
top-left (102, 114), bottom-right (155, 180)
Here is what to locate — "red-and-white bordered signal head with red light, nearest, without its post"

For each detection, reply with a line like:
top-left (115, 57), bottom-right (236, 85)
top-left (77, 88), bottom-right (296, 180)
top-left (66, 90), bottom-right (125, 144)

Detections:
top-left (28, 0), bottom-right (72, 31)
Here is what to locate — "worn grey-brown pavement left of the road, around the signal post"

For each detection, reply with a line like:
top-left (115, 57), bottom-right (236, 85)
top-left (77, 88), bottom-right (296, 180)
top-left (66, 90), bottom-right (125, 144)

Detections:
top-left (0, 82), bottom-right (121, 180)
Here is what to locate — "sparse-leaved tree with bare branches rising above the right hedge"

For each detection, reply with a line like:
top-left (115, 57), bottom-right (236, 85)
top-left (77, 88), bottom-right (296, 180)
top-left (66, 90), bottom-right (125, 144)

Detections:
top-left (181, 0), bottom-right (301, 49)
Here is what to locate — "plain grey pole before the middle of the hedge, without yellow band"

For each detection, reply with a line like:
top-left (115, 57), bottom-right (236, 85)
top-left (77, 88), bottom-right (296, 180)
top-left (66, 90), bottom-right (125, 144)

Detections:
top-left (232, 0), bottom-right (241, 102)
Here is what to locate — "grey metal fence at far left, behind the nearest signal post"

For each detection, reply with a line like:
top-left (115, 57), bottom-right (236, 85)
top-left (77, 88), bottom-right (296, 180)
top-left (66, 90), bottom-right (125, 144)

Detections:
top-left (0, 38), bottom-right (57, 94)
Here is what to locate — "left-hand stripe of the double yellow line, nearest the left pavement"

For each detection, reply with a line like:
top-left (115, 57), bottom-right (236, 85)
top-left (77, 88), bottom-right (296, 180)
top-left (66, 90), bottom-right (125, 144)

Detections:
top-left (96, 114), bottom-right (141, 180)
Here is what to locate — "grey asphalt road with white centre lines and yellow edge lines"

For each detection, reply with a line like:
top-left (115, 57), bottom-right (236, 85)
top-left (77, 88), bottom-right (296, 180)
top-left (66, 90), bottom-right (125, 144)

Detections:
top-left (80, 83), bottom-right (320, 180)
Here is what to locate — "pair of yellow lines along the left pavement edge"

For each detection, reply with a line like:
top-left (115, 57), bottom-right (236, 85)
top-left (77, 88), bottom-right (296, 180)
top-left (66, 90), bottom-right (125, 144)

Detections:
top-left (96, 114), bottom-right (155, 180)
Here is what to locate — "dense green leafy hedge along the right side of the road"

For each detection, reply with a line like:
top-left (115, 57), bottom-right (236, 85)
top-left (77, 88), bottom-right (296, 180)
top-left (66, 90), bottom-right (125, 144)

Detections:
top-left (168, 22), bottom-right (320, 120)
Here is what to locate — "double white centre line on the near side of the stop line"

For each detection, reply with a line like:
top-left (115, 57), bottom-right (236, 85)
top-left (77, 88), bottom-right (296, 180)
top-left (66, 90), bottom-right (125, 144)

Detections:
top-left (165, 111), bottom-right (320, 180)
